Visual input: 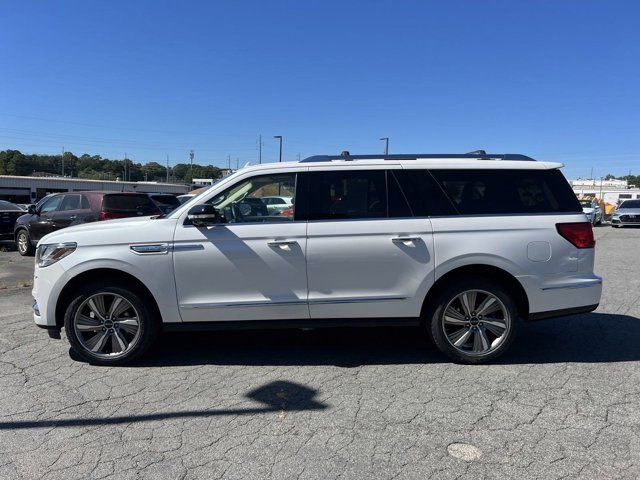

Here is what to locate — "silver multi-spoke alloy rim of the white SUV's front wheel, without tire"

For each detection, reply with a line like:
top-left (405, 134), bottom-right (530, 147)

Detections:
top-left (73, 292), bottom-right (140, 358)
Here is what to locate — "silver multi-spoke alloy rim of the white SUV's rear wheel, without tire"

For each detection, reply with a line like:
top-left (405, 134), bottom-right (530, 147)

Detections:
top-left (442, 290), bottom-right (511, 356)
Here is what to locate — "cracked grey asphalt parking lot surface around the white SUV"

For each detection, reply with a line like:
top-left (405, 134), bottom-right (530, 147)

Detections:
top-left (0, 227), bottom-right (640, 480)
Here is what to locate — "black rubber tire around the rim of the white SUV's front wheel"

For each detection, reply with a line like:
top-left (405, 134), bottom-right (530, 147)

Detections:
top-left (64, 282), bottom-right (158, 365)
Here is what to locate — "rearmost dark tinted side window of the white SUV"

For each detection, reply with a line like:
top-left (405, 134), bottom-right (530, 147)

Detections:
top-left (432, 169), bottom-right (582, 215)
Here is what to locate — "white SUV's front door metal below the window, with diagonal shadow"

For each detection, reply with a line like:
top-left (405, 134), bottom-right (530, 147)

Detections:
top-left (174, 222), bottom-right (309, 322)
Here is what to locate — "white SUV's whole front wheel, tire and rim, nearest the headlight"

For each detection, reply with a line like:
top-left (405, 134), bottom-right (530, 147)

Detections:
top-left (64, 282), bottom-right (158, 365)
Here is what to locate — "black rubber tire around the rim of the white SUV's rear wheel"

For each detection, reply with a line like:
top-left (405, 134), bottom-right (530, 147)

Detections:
top-left (424, 280), bottom-right (521, 364)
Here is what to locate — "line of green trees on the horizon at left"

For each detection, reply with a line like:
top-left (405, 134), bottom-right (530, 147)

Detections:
top-left (0, 150), bottom-right (222, 183)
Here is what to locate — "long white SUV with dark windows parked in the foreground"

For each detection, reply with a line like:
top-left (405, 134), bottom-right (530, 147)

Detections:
top-left (33, 151), bottom-right (602, 365)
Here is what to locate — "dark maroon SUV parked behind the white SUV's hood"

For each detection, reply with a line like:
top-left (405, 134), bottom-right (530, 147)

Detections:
top-left (14, 192), bottom-right (162, 255)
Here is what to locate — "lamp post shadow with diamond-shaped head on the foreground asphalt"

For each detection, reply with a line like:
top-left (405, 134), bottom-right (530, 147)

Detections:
top-left (0, 381), bottom-right (328, 431)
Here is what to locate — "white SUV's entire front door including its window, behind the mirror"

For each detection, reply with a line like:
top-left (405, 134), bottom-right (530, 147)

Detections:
top-left (174, 172), bottom-right (309, 322)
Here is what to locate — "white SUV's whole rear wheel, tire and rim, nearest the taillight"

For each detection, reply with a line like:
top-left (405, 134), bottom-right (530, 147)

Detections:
top-left (425, 280), bottom-right (519, 364)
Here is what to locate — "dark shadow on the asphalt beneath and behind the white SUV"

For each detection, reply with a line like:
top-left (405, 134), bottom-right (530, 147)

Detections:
top-left (135, 313), bottom-right (640, 368)
